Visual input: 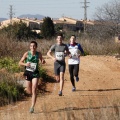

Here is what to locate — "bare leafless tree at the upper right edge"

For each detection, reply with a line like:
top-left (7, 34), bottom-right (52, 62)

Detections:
top-left (95, 0), bottom-right (120, 36)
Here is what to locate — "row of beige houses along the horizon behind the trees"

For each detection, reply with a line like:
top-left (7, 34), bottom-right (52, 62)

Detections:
top-left (0, 17), bottom-right (96, 33)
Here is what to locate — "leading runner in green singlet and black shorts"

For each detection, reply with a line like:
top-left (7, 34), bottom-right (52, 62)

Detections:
top-left (19, 41), bottom-right (45, 113)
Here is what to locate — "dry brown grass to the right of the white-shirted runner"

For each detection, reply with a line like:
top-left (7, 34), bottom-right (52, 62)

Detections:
top-left (78, 39), bottom-right (120, 55)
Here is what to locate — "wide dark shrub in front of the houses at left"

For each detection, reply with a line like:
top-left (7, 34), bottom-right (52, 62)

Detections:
top-left (0, 21), bottom-right (39, 40)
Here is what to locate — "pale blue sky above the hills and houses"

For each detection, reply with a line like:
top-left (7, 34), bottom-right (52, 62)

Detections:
top-left (0, 0), bottom-right (114, 19)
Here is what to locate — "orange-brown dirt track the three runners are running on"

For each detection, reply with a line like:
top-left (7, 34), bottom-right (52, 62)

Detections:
top-left (0, 56), bottom-right (120, 120)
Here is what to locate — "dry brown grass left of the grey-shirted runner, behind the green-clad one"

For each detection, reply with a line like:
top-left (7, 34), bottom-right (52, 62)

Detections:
top-left (0, 35), bottom-right (56, 59)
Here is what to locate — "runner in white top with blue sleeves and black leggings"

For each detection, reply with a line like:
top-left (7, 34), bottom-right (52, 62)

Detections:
top-left (68, 35), bottom-right (84, 91)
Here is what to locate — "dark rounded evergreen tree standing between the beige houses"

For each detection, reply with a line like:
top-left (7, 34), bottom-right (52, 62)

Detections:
top-left (41, 17), bottom-right (55, 39)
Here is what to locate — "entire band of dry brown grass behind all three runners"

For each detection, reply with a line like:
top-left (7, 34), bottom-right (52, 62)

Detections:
top-left (0, 36), bottom-right (120, 58)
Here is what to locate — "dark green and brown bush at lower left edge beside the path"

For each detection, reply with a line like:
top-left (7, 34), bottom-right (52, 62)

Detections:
top-left (0, 72), bottom-right (25, 106)
